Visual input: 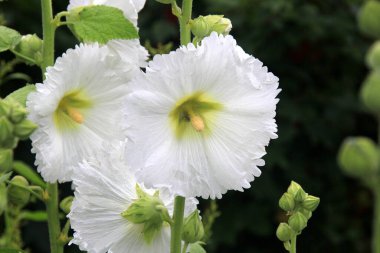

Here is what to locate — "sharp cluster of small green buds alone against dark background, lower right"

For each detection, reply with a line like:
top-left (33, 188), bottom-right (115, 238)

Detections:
top-left (276, 181), bottom-right (320, 248)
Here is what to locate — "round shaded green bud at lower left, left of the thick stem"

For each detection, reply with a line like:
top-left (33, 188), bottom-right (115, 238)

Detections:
top-left (8, 176), bottom-right (30, 207)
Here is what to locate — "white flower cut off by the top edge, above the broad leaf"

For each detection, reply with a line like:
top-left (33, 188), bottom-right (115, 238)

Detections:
top-left (67, 0), bottom-right (145, 26)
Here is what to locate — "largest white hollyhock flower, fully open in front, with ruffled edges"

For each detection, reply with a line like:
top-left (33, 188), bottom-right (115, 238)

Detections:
top-left (125, 33), bottom-right (279, 198)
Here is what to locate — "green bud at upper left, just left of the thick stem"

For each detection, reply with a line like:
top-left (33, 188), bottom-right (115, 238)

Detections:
top-left (15, 34), bottom-right (43, 65)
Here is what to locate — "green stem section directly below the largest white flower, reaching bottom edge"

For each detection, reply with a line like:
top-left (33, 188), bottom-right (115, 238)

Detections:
top-left (170, 196), bottom-right (185, 253)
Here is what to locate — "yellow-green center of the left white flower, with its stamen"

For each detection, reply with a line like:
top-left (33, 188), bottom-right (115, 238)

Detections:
top-left (54, 90), bottom-right (92, 130)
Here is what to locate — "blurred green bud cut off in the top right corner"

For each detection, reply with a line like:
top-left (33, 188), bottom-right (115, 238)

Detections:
top-left (358, 0), bottom-right (380, 38)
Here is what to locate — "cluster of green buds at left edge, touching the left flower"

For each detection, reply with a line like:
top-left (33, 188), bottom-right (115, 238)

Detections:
top-left (0, 99), bottom-right (37, 172)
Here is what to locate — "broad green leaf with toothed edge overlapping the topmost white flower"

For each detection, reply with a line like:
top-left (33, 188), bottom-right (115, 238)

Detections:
top-left (68, 5), bottom-right (139, 44)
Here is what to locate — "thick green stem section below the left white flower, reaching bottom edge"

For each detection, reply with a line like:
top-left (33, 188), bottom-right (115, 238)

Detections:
top-left (46, 183), bottom-right (63, 253)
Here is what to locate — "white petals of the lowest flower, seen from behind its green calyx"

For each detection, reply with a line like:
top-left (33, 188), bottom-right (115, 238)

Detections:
top-left (68, 142), bottom-right (196, 253)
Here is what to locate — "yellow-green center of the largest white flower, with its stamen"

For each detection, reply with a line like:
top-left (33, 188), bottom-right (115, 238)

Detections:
top-left (169, 91), bottom-right (223, 139)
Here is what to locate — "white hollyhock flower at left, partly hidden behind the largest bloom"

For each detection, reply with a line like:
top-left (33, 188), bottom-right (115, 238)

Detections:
top-left (27, 44), bottom-right (139, 182)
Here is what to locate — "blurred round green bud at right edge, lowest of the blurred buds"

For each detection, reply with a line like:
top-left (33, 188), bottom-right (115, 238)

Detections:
top-left (338, 137), bottom-right (379, 178)
